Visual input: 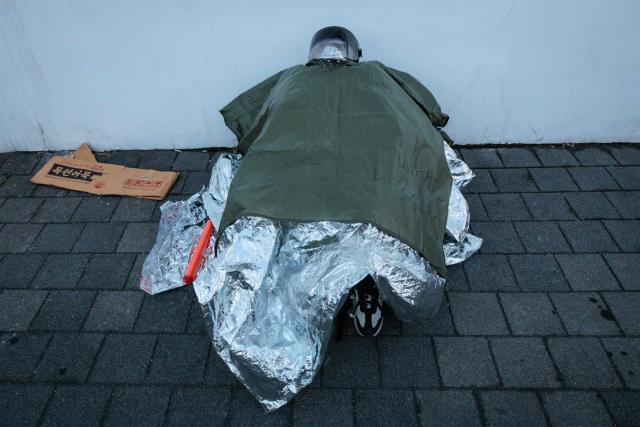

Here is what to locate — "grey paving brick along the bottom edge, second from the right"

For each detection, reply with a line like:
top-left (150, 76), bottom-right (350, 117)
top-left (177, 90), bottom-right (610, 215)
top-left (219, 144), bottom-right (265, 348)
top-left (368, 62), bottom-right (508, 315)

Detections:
top-left (543, 391), bottom-right (613, 426)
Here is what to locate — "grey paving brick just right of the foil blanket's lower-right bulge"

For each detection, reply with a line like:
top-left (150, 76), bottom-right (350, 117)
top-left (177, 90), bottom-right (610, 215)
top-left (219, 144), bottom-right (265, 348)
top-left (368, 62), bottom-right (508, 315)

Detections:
top-left (449, 292), bottom-right (509, 335)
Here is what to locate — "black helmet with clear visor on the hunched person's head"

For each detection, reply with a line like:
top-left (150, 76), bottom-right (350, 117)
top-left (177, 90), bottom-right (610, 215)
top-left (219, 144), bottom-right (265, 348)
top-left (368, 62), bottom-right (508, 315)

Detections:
top-left (309, 27), bottom-right (362, 62)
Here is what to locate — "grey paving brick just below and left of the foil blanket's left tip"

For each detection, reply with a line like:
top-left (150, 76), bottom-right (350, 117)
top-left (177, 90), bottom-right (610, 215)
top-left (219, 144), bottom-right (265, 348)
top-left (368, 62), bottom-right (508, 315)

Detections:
top-left (84, 291), bottom-right (143, 331)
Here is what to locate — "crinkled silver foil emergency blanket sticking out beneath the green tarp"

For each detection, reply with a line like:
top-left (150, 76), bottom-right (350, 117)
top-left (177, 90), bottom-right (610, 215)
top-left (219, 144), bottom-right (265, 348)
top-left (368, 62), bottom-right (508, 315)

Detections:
top-left (141, 144), bottom-right (482, 411)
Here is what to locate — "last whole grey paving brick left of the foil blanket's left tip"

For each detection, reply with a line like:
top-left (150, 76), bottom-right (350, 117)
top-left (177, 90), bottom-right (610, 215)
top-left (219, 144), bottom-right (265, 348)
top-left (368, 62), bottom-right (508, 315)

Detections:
top-left (79, 254), bottom-right (135, 289)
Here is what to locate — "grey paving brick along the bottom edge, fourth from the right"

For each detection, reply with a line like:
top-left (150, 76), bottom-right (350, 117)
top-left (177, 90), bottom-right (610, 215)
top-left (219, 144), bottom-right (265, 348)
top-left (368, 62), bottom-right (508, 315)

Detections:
top-left (416, 390), bottom-right (481, 427)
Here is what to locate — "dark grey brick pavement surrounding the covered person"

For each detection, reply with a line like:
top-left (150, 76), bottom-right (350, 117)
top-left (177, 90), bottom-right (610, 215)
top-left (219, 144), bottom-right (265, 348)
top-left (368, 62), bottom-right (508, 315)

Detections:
top-left (0, 144), bottom-right (640, 426)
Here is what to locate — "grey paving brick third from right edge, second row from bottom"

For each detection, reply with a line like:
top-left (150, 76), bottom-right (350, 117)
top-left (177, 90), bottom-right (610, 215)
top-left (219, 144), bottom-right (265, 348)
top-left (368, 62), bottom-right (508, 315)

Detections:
top-left (490, 338), bottom-right (561, 388)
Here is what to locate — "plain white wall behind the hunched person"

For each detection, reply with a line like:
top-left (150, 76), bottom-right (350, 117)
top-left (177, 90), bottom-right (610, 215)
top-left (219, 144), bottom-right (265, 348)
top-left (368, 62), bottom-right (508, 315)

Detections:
top-left (0, 0), bottom-right (640, 151)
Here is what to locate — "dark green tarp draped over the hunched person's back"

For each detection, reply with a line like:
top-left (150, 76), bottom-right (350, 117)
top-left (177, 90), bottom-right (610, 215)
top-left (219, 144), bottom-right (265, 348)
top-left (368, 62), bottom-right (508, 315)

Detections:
top-left (219, 61), bottom-right (451, 276)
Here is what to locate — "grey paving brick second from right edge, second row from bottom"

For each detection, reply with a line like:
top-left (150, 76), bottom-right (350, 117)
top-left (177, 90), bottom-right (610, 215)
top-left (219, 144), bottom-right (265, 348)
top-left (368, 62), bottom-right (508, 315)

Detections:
top-left (547, 338), bottom-right (621, 388)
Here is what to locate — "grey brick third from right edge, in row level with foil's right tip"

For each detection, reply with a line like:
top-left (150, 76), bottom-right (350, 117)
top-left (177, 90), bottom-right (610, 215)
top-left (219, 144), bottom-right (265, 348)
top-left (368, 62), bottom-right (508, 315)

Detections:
top-left (509, 254), bottom-right (569, 292)
